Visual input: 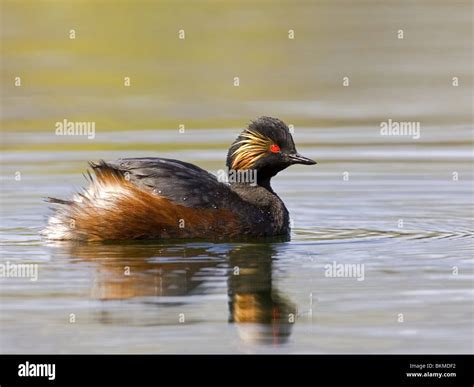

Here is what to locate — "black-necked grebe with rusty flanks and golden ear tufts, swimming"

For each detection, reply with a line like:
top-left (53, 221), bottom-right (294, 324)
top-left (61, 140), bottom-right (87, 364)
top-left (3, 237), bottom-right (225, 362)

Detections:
top-left (41, 117), bottom-right (316, 241)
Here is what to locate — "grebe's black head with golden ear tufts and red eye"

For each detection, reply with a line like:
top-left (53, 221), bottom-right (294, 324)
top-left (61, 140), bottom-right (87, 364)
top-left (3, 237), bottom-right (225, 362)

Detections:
top-left (227, 117), bottom-right (316, 184)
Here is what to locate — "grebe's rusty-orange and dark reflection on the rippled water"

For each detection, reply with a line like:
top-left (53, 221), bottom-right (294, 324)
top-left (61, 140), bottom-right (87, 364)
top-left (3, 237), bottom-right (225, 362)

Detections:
top-left (63, 243), bottom-right (296, 344)
